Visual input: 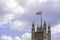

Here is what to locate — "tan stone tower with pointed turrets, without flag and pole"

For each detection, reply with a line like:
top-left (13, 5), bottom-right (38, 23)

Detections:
top-left (31, 21), bottom-right (51, 40)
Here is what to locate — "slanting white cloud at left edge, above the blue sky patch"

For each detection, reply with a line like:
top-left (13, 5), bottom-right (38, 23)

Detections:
top-left (0, 14), bottom-right (14, 26)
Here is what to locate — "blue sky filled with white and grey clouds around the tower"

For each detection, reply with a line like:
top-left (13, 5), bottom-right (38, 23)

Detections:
top-left (0, 0), bottom-right (60, 40)
